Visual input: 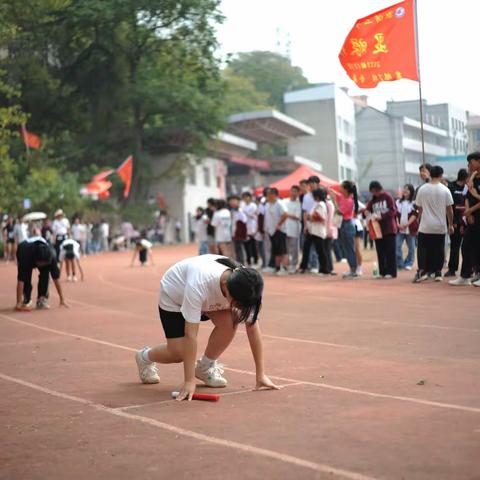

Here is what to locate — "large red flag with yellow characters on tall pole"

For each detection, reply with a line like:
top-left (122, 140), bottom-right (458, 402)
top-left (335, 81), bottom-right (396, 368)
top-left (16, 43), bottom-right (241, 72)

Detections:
top-left (338, 0), bottom-right (418, 88)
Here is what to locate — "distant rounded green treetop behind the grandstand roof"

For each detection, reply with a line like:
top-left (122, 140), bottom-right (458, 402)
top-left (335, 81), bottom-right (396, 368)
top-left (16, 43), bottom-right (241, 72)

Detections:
top-left (229, 51), bottom-right (309, 110)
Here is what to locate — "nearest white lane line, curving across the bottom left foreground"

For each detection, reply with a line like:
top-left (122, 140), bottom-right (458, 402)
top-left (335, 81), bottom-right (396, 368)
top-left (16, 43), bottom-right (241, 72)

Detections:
top-left (0, 373), bottom-right (378, 480)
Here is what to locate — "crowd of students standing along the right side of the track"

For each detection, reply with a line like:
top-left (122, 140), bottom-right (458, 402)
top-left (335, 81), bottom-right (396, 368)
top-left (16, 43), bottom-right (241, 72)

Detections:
top-left (194, 152), bottom-right (480, 286)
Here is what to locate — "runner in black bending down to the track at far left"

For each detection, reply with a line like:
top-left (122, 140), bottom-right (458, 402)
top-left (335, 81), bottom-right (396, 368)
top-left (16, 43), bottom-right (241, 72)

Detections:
top-left (15, 237), bottom-right (67, 311)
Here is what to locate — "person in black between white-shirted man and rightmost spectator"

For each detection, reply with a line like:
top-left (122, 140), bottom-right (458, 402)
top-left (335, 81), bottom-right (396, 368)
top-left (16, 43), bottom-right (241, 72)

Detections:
top-left (444, 168), bottom-right (468, 277)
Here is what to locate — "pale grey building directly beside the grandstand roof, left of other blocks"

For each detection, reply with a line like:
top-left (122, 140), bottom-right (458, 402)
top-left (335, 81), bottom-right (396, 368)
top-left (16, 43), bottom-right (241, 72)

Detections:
top-left (284, 83), bottom-right (358, 181)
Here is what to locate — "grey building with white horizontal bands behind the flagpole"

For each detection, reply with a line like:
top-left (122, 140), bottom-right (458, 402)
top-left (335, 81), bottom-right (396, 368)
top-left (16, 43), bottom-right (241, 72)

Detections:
top-left (356, 106), bottom-right (448, 194)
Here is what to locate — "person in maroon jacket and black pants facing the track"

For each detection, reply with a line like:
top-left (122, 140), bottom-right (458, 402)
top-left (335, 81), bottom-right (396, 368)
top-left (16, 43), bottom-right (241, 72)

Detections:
top-left (364, 181), bottom-right (398, 278)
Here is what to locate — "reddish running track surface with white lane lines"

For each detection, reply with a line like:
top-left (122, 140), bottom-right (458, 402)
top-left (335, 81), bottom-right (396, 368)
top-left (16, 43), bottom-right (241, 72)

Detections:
top-left (0, 247), bottom-right (480, 480)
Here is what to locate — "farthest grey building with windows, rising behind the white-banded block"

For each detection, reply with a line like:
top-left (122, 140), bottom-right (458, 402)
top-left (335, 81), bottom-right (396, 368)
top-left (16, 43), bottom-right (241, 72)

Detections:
top-left (387, 100), bottom-right (468, 156)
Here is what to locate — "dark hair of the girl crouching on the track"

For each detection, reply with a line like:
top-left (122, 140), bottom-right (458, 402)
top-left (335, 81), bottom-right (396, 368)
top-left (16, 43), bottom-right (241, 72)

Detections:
top-left (215, 257), bottom-right (263, 325)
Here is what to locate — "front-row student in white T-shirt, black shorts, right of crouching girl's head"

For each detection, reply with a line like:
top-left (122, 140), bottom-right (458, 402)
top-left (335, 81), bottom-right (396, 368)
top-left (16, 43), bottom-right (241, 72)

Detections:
top-left (265, 188), bottom-right (288, 275)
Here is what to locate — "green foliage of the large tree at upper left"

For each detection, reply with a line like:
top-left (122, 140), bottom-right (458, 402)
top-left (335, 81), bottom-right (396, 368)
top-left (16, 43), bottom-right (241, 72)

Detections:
top-left (0, 0), bottom-right (225, 203)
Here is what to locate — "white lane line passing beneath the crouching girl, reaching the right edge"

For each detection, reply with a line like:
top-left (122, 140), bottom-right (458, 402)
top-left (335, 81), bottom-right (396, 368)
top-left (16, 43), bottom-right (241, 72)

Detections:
top-left (0, 314), bottom-right (480, 413)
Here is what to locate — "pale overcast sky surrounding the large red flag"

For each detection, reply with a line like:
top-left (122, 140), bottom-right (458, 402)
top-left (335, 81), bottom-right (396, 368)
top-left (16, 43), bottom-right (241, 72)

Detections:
top-left (218, 0), bottom-right (480, 114)
